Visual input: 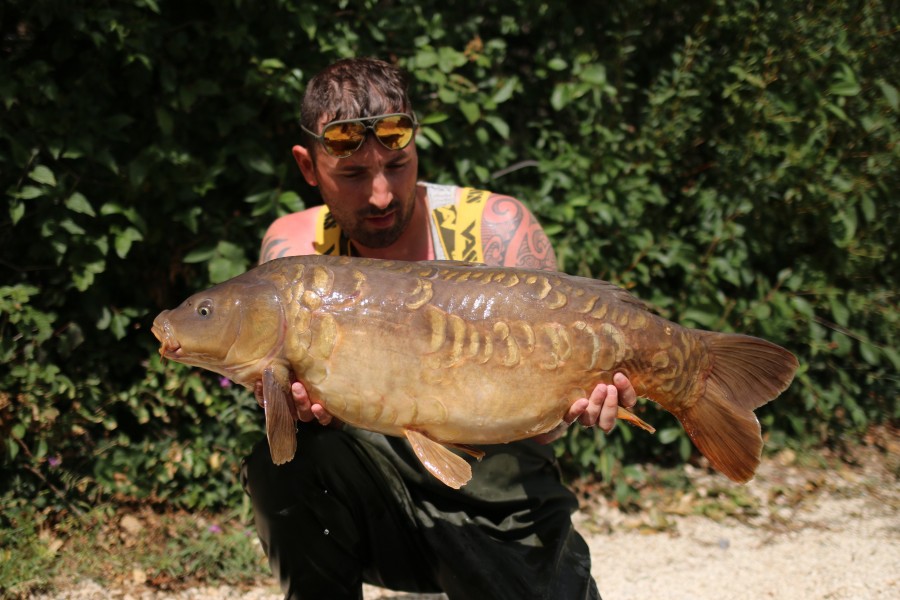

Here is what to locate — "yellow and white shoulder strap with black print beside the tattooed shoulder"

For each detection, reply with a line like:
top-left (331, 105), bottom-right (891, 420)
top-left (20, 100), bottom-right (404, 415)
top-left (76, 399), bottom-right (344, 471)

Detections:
top-left (425, 183), bottom-right (491, 262)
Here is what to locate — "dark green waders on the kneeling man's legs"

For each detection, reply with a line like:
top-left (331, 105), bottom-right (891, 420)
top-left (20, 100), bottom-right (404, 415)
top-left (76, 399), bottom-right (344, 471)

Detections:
top-left (242, 424), bottom-right (600, 600)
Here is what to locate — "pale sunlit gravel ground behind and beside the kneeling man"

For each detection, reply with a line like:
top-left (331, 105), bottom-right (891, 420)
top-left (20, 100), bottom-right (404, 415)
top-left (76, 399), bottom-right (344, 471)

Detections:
top-left (31, 448), bottom-right (900, 600)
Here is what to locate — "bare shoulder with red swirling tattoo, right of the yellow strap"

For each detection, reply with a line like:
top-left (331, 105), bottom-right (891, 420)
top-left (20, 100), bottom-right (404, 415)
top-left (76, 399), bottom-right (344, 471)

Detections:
top-left (481, 194), bottom-right (557, 271)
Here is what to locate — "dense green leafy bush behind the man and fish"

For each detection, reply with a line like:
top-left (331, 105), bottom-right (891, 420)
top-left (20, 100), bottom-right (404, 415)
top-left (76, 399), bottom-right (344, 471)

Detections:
top-left (0, 0), bottom-right (900, 520)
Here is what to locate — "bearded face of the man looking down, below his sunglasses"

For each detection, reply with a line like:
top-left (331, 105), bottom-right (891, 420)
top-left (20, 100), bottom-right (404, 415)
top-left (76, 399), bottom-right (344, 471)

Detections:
top-left (311, 122), bottom-right (419, 248)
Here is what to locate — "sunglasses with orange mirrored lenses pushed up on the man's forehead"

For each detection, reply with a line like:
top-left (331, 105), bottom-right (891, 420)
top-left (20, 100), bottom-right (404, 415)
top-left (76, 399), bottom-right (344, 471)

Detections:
top-left (300, 113), bottom-right (419, 158)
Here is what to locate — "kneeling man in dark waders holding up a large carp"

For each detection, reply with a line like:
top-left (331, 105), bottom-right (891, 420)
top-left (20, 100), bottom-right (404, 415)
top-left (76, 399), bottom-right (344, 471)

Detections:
top-left (242, 59), bottom-right (636, 600)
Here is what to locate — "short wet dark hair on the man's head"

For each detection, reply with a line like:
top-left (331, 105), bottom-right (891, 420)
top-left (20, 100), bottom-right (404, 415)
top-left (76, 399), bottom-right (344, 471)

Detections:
top-left (300, 58), bottom-right (412, 155)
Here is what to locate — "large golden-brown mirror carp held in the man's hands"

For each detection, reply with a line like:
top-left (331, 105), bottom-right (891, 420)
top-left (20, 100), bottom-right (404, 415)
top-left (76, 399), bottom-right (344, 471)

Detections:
top-left (153, 256), bottom-right (798, 488)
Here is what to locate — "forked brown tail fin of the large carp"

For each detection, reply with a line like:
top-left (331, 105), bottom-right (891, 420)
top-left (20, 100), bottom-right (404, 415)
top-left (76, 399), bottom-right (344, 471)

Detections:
top-left (674, 331), bottom-right (799, 483)
